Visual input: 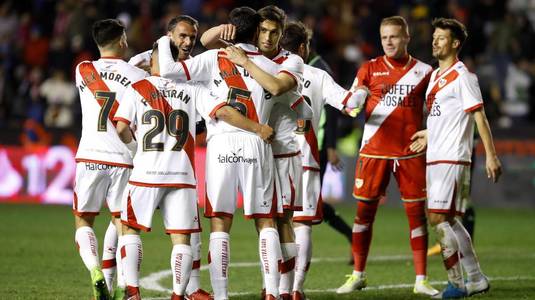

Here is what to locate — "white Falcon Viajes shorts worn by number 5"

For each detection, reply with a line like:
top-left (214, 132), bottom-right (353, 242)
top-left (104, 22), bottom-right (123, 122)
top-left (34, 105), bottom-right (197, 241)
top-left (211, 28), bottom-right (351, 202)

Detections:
top-left (204, 133), bottom-right (282, 218)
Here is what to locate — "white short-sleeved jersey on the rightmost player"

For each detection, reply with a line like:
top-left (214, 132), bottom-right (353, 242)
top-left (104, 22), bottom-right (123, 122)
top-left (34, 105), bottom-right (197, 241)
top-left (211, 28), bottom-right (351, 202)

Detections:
top-left (426, 61), bottom-right (483, 164)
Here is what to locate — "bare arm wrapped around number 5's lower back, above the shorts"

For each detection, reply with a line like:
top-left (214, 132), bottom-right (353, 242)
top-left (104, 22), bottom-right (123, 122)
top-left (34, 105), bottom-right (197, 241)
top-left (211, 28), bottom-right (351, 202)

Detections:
top-left (215, 105), bottom-right (273, 143)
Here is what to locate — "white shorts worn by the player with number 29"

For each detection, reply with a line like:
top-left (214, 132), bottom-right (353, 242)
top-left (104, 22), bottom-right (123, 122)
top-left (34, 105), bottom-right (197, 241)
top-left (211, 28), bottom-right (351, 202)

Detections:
top-left (121, 183), bottom-right (201, 233)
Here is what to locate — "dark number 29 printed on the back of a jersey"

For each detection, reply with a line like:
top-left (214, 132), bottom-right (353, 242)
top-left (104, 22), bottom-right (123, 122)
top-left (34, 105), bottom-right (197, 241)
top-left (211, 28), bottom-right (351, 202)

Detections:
top-left (141, 109), bottom-right (189, 151)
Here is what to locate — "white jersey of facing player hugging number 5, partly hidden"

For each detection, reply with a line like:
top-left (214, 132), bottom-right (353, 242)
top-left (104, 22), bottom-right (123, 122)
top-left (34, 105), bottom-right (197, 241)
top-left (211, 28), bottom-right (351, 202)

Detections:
top-left (268, 49), bottom-right (304, 156)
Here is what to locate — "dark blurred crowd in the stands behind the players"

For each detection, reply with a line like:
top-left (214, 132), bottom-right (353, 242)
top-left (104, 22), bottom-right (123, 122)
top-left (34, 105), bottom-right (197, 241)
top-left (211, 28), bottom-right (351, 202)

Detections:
top-left (0, 0), bottom-right (535, 144)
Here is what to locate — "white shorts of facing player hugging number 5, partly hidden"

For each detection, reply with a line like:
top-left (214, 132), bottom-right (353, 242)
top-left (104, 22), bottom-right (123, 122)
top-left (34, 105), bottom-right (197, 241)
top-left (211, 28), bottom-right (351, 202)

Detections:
top-left (275, 155), bottom-right (303, 211)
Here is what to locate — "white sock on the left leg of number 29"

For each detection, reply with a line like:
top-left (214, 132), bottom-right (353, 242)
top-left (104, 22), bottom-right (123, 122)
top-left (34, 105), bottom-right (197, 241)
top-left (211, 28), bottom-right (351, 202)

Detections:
top-left (121, 234), bottom-right (143, 287)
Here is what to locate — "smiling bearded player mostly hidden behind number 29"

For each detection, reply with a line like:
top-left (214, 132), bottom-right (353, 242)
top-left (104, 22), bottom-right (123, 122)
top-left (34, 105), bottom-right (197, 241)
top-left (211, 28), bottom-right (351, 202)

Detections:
top-left (128, 15), bottom-right (214, 300)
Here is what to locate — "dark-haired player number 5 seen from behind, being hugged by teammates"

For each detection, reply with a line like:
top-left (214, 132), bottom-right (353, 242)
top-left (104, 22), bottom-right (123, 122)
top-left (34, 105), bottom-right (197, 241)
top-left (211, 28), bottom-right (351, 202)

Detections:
top-left (160, 7), bottom-right (311, 299)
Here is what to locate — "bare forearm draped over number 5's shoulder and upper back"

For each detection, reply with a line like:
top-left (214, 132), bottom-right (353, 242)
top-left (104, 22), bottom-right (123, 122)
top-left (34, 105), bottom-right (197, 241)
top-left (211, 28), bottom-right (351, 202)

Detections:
top-left (221, 46), bottom-right (297, 96)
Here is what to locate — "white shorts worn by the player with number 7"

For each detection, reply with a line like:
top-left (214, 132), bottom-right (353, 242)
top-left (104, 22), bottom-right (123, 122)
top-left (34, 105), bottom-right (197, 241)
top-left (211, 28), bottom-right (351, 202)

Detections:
top-left (72, 162), bottom-right (132, 217)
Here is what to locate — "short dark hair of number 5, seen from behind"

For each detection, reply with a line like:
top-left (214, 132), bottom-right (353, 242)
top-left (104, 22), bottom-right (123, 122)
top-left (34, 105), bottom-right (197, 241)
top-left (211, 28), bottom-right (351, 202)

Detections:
top-left (229, 6), bottom-right (260, 43)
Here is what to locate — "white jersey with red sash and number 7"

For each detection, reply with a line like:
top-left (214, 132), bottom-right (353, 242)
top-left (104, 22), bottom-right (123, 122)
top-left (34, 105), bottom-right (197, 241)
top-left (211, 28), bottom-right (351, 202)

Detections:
top-left (75, 57), bottom-right (148, 167)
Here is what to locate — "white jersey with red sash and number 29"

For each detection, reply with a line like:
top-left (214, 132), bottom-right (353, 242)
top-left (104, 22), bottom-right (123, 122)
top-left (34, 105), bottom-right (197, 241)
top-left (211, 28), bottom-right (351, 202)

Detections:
top-left (115, 76), bottom-right (226, 187)
